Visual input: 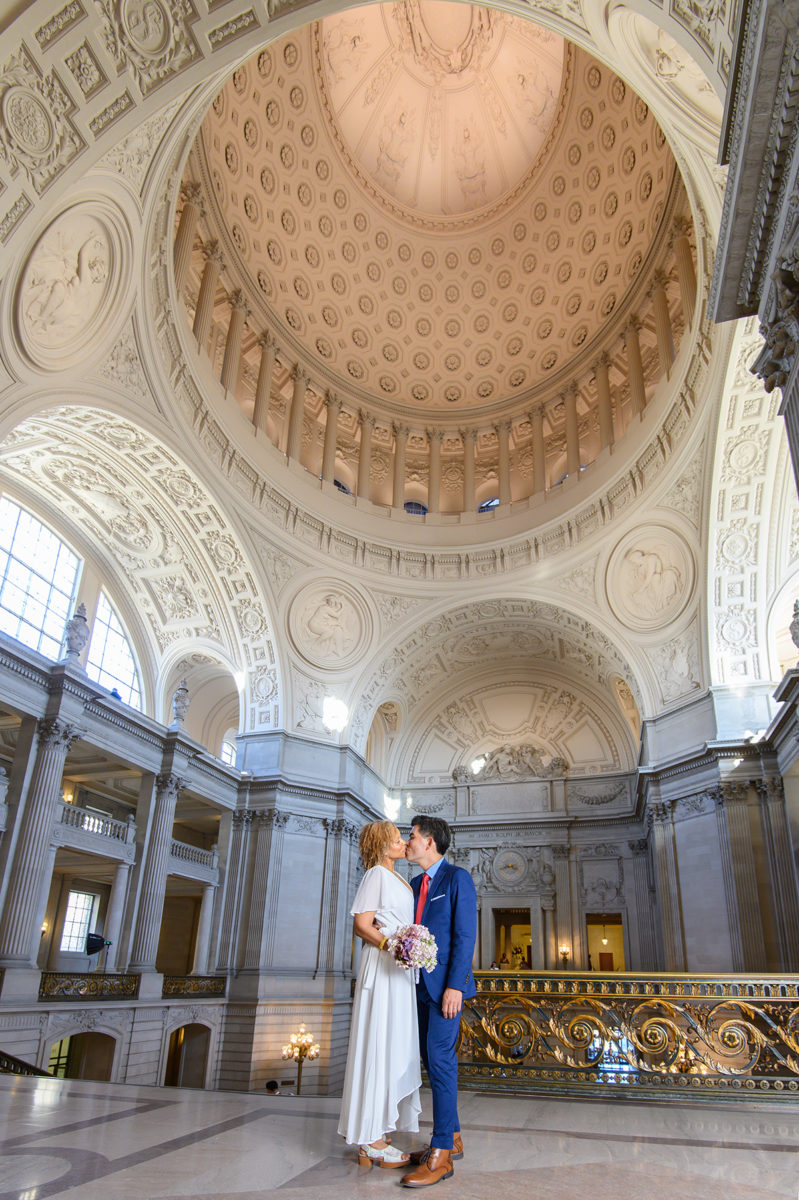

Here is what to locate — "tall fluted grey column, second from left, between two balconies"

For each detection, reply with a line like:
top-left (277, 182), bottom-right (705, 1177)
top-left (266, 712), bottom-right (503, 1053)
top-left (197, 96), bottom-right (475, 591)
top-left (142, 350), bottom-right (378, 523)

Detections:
top-left (130, 774), bottom-right (184, 974)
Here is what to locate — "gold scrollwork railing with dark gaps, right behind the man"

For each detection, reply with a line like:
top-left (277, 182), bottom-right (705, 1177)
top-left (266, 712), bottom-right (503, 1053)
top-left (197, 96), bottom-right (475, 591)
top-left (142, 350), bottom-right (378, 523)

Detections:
top-left (458, 971), bottom-right (799, 1099)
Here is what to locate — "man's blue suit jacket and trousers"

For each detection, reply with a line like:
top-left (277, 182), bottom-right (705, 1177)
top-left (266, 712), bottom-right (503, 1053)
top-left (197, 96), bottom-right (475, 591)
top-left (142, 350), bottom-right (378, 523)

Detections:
top-left (410, 859), bottom-right (477, 1150)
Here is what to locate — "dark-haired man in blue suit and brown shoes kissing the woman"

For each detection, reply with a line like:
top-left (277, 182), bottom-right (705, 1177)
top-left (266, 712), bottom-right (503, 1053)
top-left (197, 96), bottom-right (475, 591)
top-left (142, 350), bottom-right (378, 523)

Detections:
top-left (402, 816), bottom-right (477, 1188)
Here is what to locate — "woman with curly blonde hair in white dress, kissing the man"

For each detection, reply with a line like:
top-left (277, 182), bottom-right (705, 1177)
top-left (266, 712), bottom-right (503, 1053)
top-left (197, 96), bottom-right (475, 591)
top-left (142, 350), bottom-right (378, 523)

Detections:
top-left (338, 821), bottom-right (421, 1168)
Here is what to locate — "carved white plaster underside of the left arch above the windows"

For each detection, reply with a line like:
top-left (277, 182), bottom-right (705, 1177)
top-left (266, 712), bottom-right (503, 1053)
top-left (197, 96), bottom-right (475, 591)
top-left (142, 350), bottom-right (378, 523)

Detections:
top-left (0, 407), bottom-right (280, 728)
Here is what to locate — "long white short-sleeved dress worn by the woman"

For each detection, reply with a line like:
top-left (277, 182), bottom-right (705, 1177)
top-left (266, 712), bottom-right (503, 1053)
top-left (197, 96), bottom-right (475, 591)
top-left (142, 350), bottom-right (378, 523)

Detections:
top-left (338, 866), bottom-right (421, 1145)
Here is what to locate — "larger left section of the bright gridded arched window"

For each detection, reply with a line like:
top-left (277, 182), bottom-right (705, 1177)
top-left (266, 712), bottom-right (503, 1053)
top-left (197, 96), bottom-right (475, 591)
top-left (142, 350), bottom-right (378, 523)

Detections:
top-left (0, 496), bottom-right (80, 659)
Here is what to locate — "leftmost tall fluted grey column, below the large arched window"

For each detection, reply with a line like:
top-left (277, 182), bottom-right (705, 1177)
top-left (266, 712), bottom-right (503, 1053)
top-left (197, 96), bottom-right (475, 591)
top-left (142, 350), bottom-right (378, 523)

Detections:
top-left (0, 720), bottom-right (83, 967)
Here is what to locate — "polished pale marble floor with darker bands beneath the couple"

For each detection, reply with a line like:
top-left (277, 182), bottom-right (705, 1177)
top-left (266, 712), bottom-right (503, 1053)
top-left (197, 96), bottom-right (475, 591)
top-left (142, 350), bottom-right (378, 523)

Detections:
top-left (0, 1075), bottom-right (799, 1200)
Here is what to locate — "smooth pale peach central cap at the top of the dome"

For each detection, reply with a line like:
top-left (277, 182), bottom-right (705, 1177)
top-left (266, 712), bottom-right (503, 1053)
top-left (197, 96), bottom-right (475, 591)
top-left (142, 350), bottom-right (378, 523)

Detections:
top-left (313, 0), bottom-right (565, 218)
